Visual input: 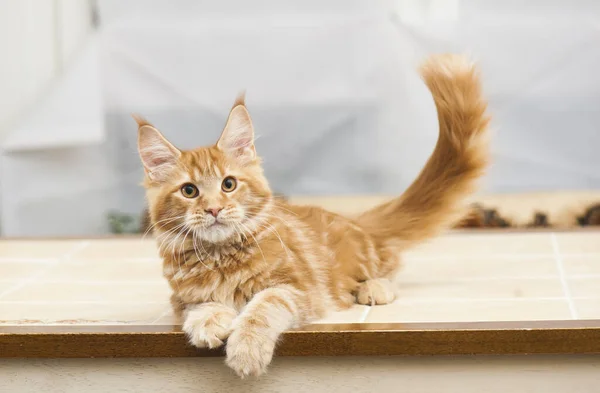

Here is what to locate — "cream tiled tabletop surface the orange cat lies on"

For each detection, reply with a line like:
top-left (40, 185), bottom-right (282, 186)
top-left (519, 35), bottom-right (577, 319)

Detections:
top-left (0, 232), bottom-right (600, 325)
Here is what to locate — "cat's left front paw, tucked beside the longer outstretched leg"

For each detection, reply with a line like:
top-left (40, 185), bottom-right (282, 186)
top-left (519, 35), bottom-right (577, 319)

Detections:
top-left (182, 303), bottom-right (237, 348)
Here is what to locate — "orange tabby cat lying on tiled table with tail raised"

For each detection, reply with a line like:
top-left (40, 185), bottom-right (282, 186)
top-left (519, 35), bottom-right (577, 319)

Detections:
top-left (137, 55), bottom-right (488, 377)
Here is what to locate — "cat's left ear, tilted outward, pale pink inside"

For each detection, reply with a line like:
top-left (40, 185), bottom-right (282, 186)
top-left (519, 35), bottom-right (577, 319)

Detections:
top-left (133, 115), bottom-right (181, 182)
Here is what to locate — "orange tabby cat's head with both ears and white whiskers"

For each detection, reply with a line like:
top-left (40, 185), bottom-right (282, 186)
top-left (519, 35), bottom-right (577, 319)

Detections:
top-left (136, 95), bottom-right (272, 243)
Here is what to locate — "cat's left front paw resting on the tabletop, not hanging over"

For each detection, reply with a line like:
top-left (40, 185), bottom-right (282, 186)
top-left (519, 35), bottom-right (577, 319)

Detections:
top-left (182, 310), bottom-right (236, 349)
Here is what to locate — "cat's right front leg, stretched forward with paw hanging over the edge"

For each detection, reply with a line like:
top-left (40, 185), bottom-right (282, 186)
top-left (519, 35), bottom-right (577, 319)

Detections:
top-left (226, 286), bottom-right (300, 378)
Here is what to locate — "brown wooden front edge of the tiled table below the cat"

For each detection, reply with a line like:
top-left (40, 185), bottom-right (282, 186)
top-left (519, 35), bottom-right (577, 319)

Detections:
top-left (0, 320), bottom-right (600, 358)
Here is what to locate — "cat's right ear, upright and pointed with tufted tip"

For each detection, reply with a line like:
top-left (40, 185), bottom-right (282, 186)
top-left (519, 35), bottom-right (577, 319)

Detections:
top-left (217, 93), bottom-right (256, 164)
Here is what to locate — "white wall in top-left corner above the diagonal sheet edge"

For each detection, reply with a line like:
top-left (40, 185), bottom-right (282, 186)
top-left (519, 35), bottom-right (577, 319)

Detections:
top-left (0, 0), bottom-right (91, 138)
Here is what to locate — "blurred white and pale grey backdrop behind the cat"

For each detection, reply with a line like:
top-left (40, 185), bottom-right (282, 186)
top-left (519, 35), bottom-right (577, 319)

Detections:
top-left (0, 0), bottom-right (600, 236)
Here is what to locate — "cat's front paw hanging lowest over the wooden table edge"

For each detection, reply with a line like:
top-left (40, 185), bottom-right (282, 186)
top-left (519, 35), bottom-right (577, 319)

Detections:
top-left (225, 329), bottom-right (275, 378)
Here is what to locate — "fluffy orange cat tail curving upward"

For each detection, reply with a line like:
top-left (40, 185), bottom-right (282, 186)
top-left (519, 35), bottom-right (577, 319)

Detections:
top-left (358, 55), bottom-right (489, 248)
